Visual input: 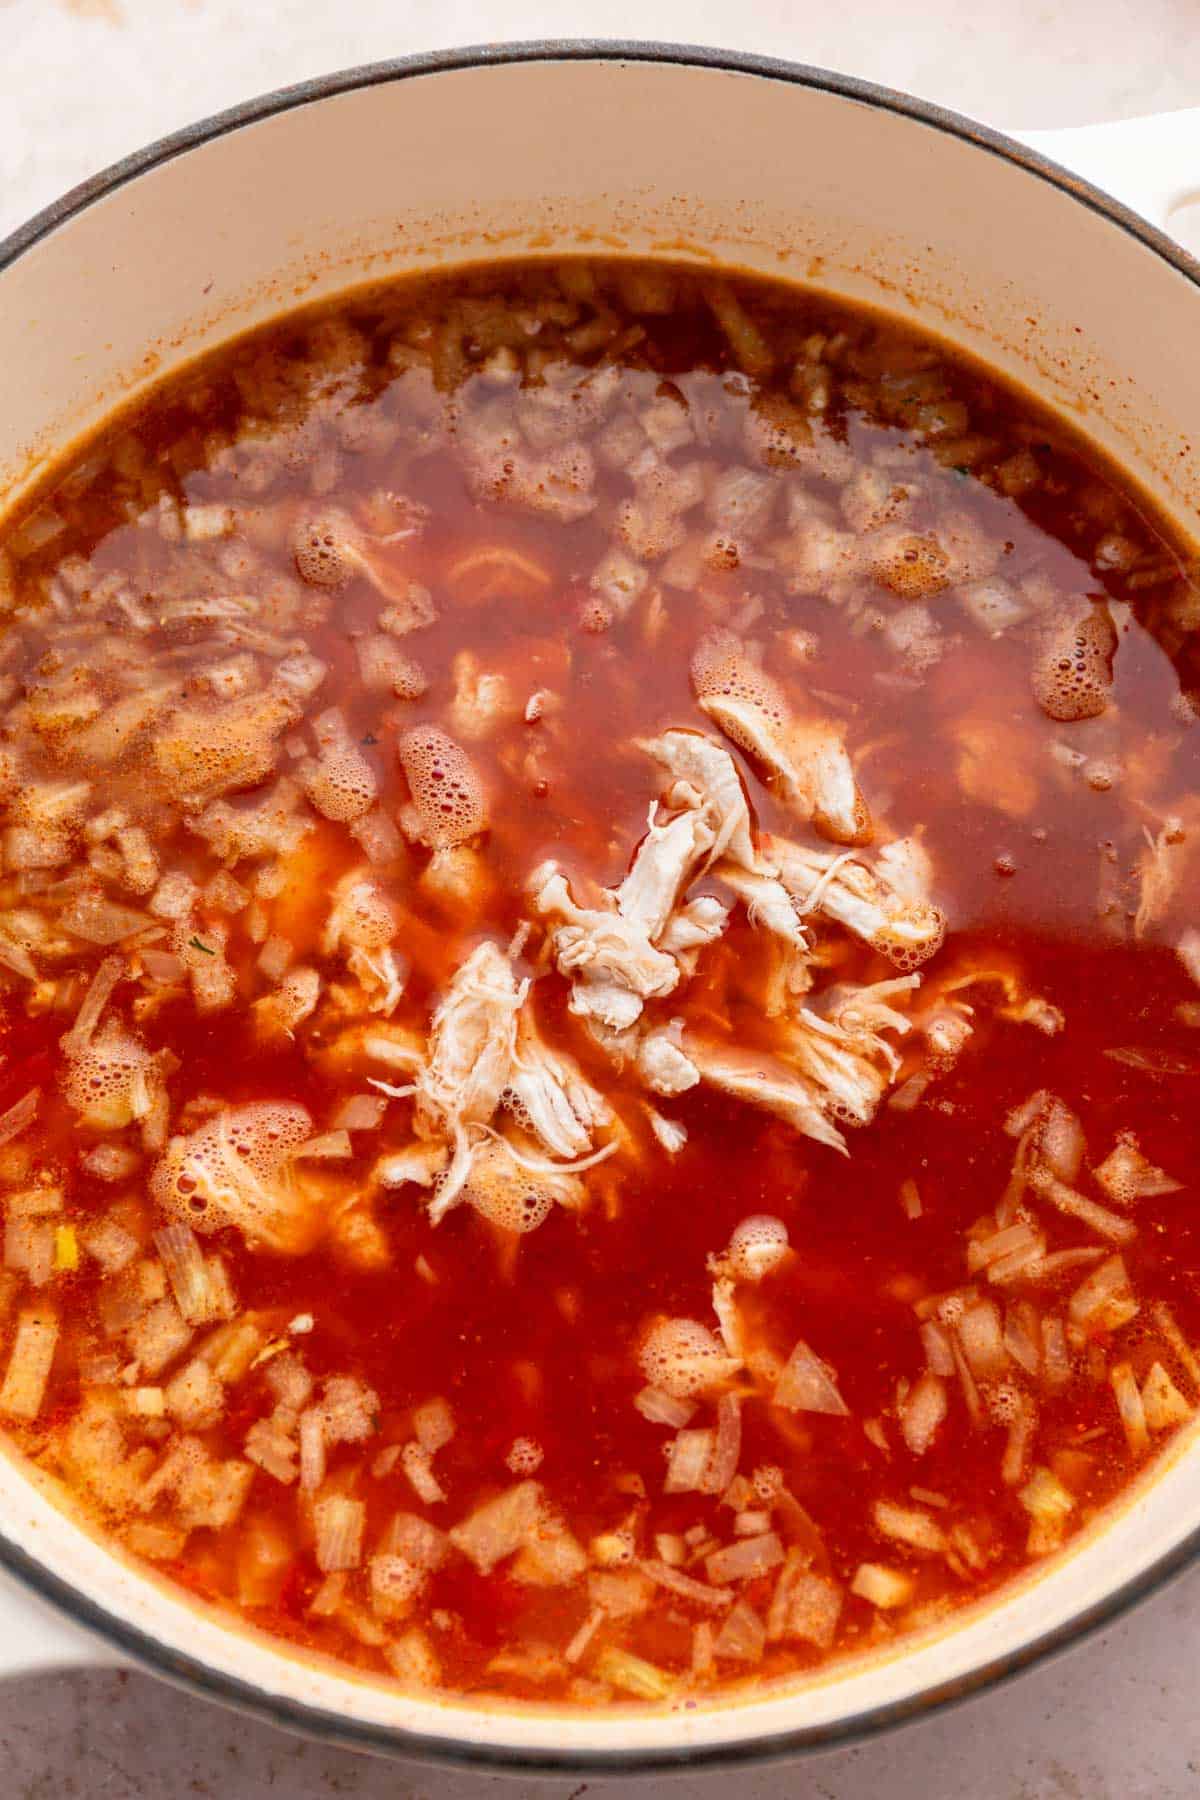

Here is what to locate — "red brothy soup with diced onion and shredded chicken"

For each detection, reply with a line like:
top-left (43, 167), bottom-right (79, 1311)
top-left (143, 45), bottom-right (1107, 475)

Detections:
top-left (0, 259), bottom-right (1200, 1705)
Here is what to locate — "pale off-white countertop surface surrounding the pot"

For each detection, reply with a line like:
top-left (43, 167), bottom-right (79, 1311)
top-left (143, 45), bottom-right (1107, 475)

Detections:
top-left (0, 0), bottom-right (1200, 1800)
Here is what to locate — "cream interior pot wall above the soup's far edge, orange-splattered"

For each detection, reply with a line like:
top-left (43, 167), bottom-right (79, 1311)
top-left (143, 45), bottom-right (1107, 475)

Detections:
top-left (0, 59), bottom-right (1200, 532)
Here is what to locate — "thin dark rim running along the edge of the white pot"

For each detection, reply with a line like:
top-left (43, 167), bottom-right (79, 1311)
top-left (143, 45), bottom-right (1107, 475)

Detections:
top-left (0, 38), bottom-right (1200, 1775)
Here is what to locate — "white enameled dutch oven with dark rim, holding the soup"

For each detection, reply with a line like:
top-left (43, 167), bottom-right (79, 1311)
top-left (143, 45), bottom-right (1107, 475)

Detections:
top-left (0, 43), bottom-right (1200, 1769)
